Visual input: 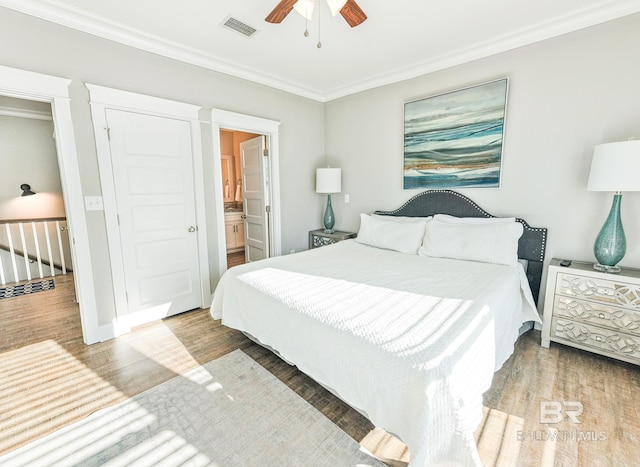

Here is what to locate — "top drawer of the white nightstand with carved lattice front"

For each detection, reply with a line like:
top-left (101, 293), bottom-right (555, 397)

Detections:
top-left (556, 273), bottom-right (640, 310)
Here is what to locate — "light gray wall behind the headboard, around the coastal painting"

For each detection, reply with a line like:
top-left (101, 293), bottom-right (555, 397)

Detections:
top-left (324, 14), bottom-right (640, 306)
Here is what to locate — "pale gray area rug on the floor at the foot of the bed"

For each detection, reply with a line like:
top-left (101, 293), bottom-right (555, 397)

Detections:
top-left (0, 350), bottom-right (384, 467)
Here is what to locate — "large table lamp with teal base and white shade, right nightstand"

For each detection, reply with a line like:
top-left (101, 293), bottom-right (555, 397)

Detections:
top-left (587, 141), bottom-right (640, 272)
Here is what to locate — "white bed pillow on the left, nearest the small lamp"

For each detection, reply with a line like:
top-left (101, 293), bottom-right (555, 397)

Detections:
top-left (355, 214), bottom-right (427, 255)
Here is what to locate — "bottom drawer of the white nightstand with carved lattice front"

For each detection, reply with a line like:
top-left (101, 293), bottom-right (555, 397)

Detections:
top-left (551, 317), bottom-right (640, 363)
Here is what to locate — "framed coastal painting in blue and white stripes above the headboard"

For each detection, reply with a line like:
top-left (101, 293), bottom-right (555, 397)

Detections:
top-left (403, 78), bottom-right (509, 189)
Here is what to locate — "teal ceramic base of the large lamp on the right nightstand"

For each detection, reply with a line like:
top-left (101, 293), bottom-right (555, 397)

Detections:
top-left (593, 193), bottom-right (627, 272)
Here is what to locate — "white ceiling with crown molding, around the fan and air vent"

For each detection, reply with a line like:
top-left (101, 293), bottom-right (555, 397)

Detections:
top-left (0, 0), bottom-right (640, 102)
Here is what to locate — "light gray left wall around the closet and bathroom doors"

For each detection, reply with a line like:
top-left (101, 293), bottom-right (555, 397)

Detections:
top-left (0, 8), bottom-right (324, 325)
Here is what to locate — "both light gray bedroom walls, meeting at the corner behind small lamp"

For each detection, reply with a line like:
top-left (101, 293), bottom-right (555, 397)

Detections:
top-left (0, 8), bottom-right (640, 324)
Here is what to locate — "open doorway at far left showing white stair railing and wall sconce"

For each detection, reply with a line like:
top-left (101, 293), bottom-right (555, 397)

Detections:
top-left (0, 96), bottom-right (73, 292)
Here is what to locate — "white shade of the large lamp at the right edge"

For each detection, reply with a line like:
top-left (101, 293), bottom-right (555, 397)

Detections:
top-left (587, 140), bottom-right (640, 191)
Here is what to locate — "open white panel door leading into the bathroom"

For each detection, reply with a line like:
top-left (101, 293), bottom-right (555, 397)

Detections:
top-left (240, 136), bottom-right (269, 262)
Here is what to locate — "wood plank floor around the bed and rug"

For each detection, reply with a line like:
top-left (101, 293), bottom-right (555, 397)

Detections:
top-left (0, 276), bottom-right (640, 466)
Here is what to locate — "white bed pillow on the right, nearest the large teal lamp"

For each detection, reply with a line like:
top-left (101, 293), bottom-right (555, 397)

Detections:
top-left (418, 218), bottom-right (524, 266)
